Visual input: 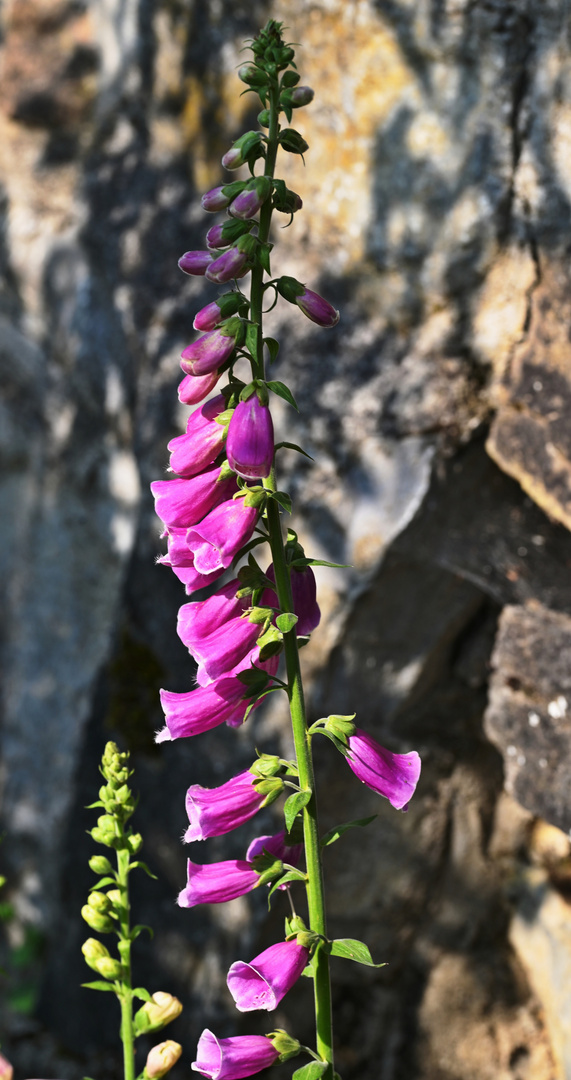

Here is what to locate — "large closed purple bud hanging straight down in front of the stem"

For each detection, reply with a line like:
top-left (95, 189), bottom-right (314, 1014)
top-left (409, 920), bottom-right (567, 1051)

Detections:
top-left (227, 393), bottom-right (274, 480)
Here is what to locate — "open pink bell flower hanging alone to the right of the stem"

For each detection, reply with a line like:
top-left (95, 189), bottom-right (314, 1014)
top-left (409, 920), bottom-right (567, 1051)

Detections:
top-left (346, 728), bottom-right (421, 810)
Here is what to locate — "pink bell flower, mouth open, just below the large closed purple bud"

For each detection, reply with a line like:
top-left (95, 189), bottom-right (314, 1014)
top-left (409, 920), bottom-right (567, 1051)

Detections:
top-left (187, 499), bottom-right (258, 573)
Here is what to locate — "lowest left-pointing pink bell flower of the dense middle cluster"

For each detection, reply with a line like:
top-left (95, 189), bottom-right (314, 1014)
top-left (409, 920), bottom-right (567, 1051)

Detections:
top-left (157, 678), bottom-right (248, 742)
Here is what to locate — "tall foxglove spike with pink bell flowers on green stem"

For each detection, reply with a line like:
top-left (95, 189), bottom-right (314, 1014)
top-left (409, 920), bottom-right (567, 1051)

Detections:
top-left (152, 19), bottom-right (420, 1080)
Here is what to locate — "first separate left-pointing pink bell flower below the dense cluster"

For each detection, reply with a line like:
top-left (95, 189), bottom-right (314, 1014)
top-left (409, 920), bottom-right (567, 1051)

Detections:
top-left (183, 770), bottom-right (266, 843)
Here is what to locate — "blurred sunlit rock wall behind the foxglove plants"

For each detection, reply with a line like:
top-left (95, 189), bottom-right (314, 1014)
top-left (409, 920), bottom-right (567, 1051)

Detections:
top-left (0, 0), bottom-right (571, 1080)
